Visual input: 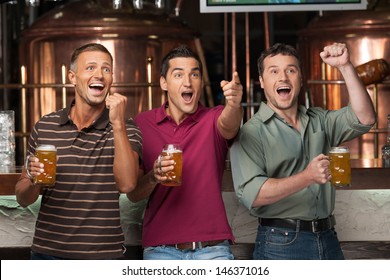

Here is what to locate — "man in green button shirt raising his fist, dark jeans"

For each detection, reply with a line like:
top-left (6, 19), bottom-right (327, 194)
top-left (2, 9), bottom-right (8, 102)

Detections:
top-left (231, 43), bottom-right (375, 259)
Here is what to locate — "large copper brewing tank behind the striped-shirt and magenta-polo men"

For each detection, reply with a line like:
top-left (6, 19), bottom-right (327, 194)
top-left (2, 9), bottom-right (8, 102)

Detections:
top-left (20, 0), bottom-right (207, 133)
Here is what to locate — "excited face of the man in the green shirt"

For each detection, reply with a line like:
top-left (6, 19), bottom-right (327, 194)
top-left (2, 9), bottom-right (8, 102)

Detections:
top-left (259, 54), bottom-right (302, 113)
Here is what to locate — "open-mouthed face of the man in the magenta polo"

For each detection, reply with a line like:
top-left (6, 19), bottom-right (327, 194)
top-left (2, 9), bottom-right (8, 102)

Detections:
top-left (160, 57), bottom-right (203, 123)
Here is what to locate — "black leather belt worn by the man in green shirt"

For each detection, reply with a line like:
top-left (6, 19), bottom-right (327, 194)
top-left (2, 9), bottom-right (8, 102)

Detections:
top-left (259, 215), bottom-right (336, 233)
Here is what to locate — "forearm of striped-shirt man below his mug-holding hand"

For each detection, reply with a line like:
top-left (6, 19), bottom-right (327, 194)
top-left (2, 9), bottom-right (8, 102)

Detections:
top-left (15, 170), bottom-right (41, 207)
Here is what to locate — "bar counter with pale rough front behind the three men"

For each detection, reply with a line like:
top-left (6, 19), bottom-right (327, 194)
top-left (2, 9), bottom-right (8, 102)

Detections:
top-left (0, 160), bottom-right (390, 259)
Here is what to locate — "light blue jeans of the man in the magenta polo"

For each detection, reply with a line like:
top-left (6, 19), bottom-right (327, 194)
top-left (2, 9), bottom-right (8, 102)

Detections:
top-left (144, 240), bottom-right (234, 260)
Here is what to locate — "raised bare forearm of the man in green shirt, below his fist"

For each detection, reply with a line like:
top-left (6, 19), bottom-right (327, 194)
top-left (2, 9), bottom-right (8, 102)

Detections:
top-left (339, 63), bottom-right (375, 125)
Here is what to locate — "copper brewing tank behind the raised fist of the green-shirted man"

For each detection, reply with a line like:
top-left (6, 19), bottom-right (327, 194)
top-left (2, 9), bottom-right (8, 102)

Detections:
top-left (298, 1), bottom-right (390, 159)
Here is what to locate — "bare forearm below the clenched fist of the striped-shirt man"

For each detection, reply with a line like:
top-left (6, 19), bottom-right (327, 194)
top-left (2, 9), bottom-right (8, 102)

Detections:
top-left (113, 127), bottom-right (139, 193)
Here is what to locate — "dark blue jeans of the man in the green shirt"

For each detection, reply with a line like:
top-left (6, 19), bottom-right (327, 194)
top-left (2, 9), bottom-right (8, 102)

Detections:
top-left (253, 225), bottom-right (344, 260)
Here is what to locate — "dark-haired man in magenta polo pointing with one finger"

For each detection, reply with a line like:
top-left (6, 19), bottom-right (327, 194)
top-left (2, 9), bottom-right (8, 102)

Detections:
top-left (128, 46), bottom-right (243, 260)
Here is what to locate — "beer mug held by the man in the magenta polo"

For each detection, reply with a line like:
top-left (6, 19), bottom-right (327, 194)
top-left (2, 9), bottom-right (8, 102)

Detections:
top-left (161, 144), bottom-right (183, 187)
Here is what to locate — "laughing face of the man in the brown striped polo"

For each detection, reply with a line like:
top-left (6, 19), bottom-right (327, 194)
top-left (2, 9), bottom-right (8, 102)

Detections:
top-left (69, 51), bottom-right (113, 106)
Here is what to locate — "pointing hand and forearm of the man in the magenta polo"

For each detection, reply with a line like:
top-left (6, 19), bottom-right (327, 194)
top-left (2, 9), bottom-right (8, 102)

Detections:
top-left (218, 72), bottom-right (244, 139)
